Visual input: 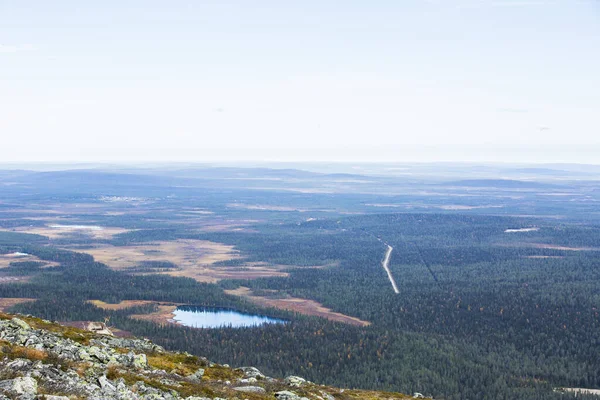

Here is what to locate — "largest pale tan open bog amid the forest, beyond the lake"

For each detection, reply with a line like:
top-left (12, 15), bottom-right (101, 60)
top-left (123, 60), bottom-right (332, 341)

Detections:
top-left (72, 239), bottom-right (290, 283)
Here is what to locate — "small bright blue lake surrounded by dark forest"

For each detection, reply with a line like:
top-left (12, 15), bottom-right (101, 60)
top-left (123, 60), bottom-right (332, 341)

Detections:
top-left (173, 306), bottom-right (287, 328)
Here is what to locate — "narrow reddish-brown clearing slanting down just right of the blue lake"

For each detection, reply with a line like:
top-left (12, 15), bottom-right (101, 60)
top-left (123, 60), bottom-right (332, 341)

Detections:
top-left (225, 286), bottom-right (371, 326)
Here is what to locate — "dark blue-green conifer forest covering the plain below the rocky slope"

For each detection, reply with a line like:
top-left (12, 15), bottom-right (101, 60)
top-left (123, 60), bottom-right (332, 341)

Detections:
top-left (0, 167), bottom-right (600, 399)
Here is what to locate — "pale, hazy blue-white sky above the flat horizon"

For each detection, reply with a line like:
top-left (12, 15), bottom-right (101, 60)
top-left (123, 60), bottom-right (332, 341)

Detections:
top-left (0, 0), bottom-right (600, 164)
